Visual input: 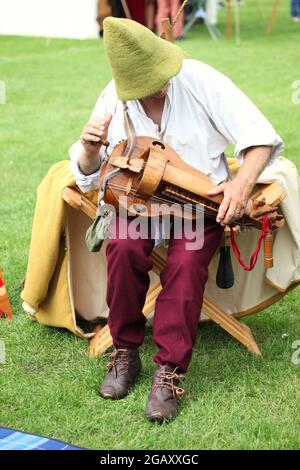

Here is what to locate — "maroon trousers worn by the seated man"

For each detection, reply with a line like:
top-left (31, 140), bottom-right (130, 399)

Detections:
top-left (106, 219), bottom-right (223, 372)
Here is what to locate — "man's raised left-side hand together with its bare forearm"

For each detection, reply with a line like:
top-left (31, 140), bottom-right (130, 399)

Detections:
top-left (78, 114), bottom-right (112, 175)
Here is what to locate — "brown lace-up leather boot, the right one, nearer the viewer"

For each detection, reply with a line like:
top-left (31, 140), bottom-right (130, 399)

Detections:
top-left (146, 365), bottom-right (184, 421)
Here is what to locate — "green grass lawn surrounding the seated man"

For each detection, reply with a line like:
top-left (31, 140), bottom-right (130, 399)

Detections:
top-left (0, 0), bottom-right (300, 449)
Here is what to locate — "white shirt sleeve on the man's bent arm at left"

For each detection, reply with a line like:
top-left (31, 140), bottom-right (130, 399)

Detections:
top-left (69, 81), bottom-right (117, 193)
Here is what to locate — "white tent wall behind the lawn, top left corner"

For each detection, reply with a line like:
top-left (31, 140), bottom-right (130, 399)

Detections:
top-left (0, 0), bottom-right (99, 39)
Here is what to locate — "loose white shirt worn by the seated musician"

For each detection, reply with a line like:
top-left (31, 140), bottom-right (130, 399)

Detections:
top-left (69, 59), bottom-right (283, 192)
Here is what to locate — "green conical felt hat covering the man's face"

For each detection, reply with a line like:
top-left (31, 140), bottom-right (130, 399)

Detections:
top-left (103, 17), bottom-right (183, 101)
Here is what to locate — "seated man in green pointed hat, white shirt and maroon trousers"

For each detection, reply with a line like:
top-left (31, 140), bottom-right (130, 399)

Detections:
top-left (70, 17), bottom-right (283, 421)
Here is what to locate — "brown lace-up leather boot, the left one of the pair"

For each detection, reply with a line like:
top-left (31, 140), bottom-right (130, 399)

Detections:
top-left (99, 348), bottom-right (142, 400)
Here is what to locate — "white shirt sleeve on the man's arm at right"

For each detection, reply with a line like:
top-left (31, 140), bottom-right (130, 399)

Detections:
top-left (190, 64), bottom-right (284, 165)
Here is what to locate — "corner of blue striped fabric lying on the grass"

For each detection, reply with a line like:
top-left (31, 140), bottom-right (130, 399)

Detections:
top-left (0, 427), bottom-right (81, 450)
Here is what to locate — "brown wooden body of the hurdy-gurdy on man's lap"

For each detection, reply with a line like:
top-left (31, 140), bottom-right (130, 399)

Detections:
top-left (100, 137), bottom-right (222, 216)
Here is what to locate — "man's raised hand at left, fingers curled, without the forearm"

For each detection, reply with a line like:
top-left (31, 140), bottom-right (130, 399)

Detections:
top-left (80, 114), bottom-right (112, 158)
